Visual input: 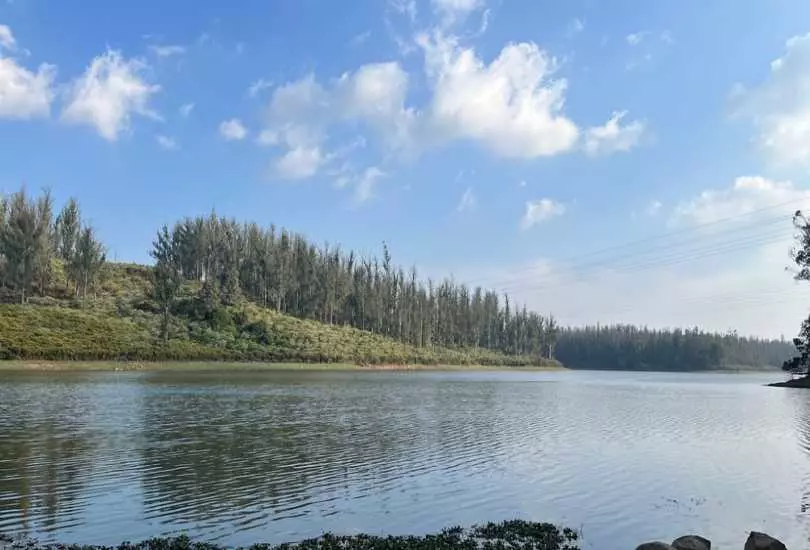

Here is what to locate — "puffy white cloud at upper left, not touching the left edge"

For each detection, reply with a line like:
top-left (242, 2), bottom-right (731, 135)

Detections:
top-left (62, 50), bottom-right (160, 141)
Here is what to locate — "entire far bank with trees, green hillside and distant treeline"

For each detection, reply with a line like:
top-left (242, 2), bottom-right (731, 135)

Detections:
top-left (0, 190), bottom-right (791, 370)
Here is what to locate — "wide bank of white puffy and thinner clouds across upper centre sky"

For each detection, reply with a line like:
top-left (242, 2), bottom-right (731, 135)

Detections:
top-left (256, 29), bottom-right (644, 196)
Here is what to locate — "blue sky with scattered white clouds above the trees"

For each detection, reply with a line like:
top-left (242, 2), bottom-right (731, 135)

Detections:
top-left (0, 0), bottom-right (810, 338)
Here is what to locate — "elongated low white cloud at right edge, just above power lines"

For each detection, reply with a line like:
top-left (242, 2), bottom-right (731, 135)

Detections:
top-left (672, 176), bottom-right (810, 224)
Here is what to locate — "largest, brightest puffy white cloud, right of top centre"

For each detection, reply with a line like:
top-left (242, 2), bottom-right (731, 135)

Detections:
top-left (418, 35), bottom-right (578, 158)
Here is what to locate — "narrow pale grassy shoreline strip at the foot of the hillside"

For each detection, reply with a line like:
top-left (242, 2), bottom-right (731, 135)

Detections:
top-left (0, 360), bottom-right (568, 372)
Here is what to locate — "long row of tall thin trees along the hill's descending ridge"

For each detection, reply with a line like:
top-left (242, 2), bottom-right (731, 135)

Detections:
top-left (151, 214), bottom-right (558, 358)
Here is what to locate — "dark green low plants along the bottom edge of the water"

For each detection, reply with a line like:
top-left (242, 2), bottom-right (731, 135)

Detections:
top-left (0, 520), bottom-right (579, 550)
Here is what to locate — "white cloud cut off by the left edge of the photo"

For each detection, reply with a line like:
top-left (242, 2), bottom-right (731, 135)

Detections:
top-left (0, 57), bottom-right (56, 119)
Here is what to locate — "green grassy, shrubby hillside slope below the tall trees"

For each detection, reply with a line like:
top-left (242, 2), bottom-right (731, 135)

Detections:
top-left (0, 263), bottom-right (556, 366)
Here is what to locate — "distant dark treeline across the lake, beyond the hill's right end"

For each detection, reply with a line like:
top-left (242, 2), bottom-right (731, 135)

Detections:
top-left (556, 325), bottom-right (794, 371)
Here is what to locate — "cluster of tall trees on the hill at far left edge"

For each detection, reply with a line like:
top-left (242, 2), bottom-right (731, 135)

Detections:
top-left (0, 188), bottom-right (105, 304)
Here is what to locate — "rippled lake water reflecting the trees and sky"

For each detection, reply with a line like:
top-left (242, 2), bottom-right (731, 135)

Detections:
top-left (0, 371), bottom-right (810, 550)
